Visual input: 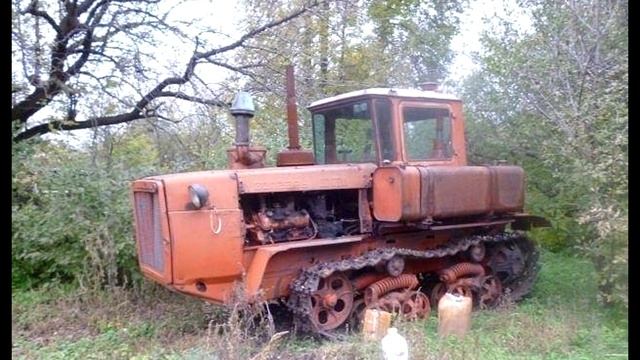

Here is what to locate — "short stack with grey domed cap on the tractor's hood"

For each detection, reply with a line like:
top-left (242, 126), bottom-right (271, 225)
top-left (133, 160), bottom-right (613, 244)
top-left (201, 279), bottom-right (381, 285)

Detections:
top-left (227, 91), bottom-right (267, 169)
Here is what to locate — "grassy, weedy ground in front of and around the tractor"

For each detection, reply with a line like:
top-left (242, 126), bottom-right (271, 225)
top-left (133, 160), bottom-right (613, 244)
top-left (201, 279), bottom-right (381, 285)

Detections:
top-left (12, 252), bottom-right (628, 360)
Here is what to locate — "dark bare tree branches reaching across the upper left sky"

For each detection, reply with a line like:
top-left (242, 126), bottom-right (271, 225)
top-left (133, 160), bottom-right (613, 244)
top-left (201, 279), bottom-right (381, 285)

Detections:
top-left (12, 0), bottom-right (318, 141)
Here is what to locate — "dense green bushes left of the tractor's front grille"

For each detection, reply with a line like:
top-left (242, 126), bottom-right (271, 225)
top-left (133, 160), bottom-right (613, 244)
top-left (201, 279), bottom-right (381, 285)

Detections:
top-left (12, 128), bottom-right (160, 287)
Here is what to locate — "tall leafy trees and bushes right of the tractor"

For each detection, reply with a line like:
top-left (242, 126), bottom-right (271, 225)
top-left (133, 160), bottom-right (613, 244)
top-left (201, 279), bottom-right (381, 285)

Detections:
top-left (465, 0), bottom-right (628, 306)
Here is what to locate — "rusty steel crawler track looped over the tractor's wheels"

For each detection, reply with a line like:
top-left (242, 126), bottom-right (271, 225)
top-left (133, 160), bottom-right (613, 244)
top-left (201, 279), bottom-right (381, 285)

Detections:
top-left (287, 231), bottom-right (538, 334)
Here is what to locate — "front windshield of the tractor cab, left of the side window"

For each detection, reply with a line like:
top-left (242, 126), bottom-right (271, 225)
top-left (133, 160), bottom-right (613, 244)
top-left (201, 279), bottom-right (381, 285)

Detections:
top-left (313, 100), bottom-right (377, 164)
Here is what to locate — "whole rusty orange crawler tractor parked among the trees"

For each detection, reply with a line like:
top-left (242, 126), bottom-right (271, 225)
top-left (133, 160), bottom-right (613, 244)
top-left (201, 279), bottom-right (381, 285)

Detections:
top-left (132, 67), bottom-right (547, 333)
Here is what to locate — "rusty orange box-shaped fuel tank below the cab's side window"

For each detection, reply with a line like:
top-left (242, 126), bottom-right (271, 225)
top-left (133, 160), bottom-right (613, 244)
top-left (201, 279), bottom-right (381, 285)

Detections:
top-left (373, 166), bottom-right (524, 222)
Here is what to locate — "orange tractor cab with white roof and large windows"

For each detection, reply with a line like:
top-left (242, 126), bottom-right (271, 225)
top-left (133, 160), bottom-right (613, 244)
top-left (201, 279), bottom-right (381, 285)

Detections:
top-left (308, 88), bottom-right (466, 165)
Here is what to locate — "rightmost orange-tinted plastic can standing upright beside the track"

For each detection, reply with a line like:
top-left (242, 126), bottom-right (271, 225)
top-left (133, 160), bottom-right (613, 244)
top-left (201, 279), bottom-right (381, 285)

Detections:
top-left (438, 293), bottom-right (472, 337)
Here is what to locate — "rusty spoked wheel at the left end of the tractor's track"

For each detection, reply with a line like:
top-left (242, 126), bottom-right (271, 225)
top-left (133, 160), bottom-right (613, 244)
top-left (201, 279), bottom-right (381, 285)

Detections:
top-left (310, 274), bottom-right (353, 331)
